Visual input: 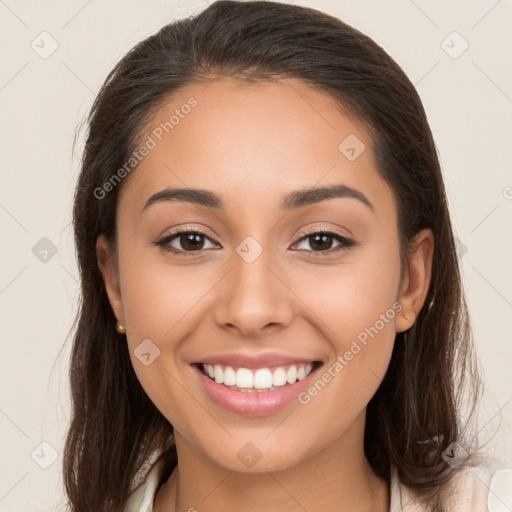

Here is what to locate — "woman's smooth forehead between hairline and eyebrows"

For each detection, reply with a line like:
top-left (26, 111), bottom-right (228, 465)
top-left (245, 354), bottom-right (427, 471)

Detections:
top-left (122, 79), bottom-right (389, 217)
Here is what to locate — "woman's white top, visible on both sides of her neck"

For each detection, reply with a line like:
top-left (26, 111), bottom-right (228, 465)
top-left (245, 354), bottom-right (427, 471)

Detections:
top-left (125, 460), bottom-right (512, 512)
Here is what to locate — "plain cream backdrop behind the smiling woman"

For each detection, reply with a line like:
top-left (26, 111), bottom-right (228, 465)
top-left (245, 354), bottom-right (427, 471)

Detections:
top-left (0, 0), bottom-right (512, 512)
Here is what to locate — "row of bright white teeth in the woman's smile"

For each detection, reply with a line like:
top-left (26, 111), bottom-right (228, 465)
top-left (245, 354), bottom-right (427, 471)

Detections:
top-left (202, 363), bottom-right (313, 391)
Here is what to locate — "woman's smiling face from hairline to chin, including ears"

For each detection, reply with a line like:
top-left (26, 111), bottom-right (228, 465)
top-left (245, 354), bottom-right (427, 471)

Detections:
top-left (98, 79), bottom-right (432, 471)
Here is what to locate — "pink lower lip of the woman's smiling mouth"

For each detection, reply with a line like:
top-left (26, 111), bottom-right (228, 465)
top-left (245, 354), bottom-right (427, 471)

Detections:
top-left (193, 365), bottom-right (320, 416)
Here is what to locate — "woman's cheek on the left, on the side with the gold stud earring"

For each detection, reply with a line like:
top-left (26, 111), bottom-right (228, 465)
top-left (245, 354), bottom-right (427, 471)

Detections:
top-left (116, 250), bottom-right (217, 431)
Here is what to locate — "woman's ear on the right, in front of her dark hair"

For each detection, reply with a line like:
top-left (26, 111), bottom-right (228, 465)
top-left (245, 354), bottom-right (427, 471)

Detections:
top-left (395, 229), bottom-right (434, 332)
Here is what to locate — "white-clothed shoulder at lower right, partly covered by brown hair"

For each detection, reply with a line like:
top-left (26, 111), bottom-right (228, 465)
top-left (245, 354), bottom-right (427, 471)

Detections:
top-left (392, 461), bottom-right (512, 512)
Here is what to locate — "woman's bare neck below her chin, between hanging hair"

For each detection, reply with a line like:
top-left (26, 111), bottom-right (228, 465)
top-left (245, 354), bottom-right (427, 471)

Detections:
top-left (154, 417), bottom-right (390, 512)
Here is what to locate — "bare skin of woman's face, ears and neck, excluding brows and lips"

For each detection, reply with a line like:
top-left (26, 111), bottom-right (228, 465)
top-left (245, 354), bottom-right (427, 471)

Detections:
top-left (97, 79), bottom-right (434, 512)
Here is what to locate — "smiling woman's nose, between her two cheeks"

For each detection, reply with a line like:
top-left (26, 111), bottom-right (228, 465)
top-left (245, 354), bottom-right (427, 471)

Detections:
top-left (214, 242), bottom-right (294, 337)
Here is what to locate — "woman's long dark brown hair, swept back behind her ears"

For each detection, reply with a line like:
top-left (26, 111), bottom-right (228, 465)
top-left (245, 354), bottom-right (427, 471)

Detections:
top-left (63, 0), bottom-right (478, 512)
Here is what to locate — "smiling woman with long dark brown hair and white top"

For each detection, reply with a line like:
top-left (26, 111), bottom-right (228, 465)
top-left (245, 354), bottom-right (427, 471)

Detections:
top-left (64, 1), bottom-right (504, 512)
